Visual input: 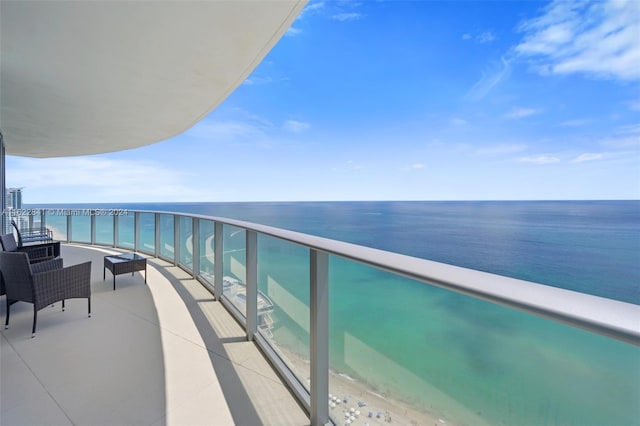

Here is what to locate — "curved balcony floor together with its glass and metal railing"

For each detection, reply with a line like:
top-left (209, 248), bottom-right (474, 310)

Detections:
top-left (2, 210), bottom-right (640, 425)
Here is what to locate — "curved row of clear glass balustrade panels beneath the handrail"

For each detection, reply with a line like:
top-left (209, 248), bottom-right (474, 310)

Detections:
top-left (21, 211), bottom-right (640, 425)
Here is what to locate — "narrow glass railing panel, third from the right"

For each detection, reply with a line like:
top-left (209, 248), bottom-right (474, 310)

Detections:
top-left (222, 225), bottom-right (247, 317)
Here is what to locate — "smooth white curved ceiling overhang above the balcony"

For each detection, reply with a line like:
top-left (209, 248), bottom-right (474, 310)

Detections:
top-left (0, 0), bottom-right (306, 157)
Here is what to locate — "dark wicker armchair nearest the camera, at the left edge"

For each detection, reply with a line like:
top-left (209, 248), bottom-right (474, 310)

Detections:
top-left (0, 252), bottom-right (91, 337)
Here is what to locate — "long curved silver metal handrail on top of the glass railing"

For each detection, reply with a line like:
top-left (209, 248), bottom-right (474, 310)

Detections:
top-left (136, 210), bottom-right (640, 346)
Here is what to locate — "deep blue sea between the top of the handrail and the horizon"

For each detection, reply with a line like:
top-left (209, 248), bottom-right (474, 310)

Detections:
top-left (37, 201), bottom-right (640, 304)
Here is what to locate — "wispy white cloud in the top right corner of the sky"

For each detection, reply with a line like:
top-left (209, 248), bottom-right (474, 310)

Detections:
top-left (515, 0), bottom-right (640, 80)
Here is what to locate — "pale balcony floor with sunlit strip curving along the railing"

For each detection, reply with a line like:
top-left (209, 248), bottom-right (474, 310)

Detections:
top-left (0, 245), bottom-right (309, 425)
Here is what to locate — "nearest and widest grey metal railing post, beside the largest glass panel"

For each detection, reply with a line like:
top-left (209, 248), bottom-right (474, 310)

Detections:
top-left (310, 250), bottom-right (331, 426)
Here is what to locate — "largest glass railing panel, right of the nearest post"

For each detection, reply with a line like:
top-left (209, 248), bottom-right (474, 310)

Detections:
top-left (329, 256), bottom-right (640, 425)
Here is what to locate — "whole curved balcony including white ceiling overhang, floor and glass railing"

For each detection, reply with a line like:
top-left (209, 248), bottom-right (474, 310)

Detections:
top-left (0, 0), bottom-right (640, 425)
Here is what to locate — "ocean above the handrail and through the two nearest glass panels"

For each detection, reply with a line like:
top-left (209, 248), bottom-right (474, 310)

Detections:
top-left (28, 201), bottom-right (640, 425)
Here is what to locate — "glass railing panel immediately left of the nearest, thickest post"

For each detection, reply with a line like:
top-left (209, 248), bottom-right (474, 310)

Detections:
top-left (258, 235), bottom-right (311, 390)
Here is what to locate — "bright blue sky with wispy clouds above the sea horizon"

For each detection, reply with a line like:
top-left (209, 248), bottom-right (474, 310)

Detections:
top-left (7, 0), bottom-right (640, 203)
